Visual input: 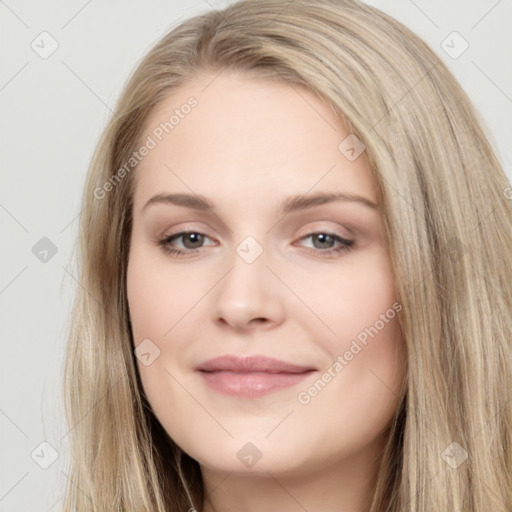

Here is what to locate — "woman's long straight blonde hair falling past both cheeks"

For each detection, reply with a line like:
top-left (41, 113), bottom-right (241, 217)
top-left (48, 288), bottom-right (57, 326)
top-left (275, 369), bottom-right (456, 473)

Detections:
top-left (64, 0), bottom-right (512, 512)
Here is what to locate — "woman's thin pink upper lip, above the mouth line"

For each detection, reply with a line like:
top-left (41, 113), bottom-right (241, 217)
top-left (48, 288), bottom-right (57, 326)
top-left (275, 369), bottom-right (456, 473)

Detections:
top-left (194, 355), bottom-right (315, 373)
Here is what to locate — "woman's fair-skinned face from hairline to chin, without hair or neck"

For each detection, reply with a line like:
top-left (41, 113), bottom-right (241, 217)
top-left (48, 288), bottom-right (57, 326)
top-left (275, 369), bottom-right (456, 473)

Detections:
top-left (127, 72), bottom-right (404, 475)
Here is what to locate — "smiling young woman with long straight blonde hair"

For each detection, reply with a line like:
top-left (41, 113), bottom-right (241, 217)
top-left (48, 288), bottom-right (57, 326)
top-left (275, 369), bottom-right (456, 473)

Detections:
top-left (65, 0), bottom-right (512, 512)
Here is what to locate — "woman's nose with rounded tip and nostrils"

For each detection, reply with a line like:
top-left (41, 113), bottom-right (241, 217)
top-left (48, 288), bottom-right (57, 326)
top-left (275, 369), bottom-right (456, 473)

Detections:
top-left (212, 243), bottom-right (285, 332)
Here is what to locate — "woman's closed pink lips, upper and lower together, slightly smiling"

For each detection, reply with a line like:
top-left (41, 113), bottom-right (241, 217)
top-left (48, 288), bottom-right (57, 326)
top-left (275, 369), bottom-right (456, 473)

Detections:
top-left (195, 355), bottom-right (316, 398)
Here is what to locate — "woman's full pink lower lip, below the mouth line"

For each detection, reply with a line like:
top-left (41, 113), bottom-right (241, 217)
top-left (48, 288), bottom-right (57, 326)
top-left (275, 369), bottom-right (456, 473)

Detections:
top-left (199, 370), bottom-right (313, 398)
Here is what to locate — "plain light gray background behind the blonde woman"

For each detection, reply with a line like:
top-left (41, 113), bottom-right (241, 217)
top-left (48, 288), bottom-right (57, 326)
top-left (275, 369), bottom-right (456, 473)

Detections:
top-left (0, 0), bottom-right (512, 512)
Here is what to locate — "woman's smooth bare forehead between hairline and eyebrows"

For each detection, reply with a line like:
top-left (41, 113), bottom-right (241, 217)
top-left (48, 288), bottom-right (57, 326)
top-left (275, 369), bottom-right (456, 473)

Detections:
top-left (135, 71), bottom-right (376, 210)
